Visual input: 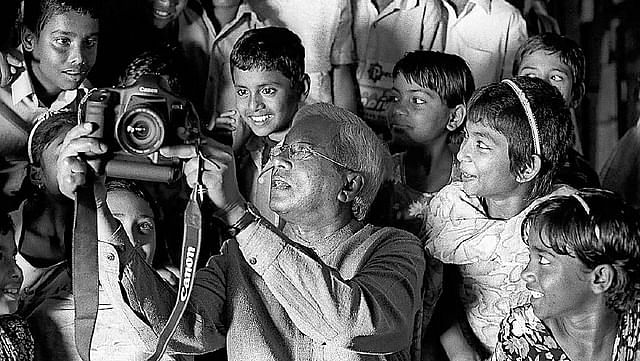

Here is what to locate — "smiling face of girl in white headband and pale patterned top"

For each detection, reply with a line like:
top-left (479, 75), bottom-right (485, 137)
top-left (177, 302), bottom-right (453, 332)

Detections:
top-left (457, 121), bottom-right (520, 200)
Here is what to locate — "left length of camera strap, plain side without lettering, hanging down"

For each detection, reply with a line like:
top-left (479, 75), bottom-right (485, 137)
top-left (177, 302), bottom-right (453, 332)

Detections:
top-left (71, 185), bottom-right (98, 361)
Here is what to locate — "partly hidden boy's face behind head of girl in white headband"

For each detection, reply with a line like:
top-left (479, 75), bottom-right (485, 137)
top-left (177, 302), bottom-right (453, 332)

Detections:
top-left (517, 50), bottom-right (574, 106)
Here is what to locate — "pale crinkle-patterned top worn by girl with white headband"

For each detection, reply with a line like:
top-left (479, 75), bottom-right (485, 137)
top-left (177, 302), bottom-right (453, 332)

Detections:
top-left (425, 182), bottom-right (574, 350)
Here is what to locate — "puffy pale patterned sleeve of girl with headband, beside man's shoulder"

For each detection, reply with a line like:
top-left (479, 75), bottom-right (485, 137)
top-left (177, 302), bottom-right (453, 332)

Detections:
top-left (425, 182), bottom-right (506, 264)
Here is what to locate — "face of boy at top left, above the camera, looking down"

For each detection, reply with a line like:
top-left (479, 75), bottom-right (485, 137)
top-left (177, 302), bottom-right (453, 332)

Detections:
top-left (23, 11), bottom-right (98, 95)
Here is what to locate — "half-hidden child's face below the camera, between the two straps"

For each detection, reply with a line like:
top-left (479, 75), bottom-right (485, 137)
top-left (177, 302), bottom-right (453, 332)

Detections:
top-left (107, 189), bottom-right (156, 264)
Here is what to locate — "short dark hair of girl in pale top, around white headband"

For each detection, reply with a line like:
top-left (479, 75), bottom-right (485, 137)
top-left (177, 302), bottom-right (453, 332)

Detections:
top-left (467, 76), bottom-right (572, 200)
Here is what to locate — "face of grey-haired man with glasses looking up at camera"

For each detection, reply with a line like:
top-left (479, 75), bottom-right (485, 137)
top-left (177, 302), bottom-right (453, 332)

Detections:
top-left (269, 116), bottom-right (344, 223)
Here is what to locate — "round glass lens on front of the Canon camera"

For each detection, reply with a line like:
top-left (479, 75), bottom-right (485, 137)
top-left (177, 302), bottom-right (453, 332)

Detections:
top-left (116, 107), bottom-right (165, 155)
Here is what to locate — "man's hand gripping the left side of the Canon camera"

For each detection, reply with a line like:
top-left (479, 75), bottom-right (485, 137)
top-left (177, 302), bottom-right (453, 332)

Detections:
top-left (57, 123), bottom-right (107, 199)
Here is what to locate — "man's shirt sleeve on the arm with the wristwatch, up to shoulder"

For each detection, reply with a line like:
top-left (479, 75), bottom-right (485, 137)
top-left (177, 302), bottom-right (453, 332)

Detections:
top-left (236, 221), bottom-right (425, 354)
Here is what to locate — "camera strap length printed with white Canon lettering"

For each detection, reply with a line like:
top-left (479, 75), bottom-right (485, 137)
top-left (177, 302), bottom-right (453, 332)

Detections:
top-left (147, 179), bottom-right (205, 361)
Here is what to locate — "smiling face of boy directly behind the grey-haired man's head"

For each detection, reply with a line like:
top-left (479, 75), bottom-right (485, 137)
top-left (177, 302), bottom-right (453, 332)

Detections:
top-left (233, 68), bottom-right (302, 137)
